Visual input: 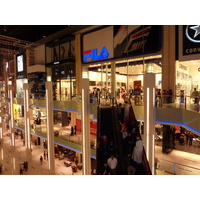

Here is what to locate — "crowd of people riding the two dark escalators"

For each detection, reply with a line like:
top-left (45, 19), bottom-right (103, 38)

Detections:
top-left (98, 101), bottom-right (143, 175)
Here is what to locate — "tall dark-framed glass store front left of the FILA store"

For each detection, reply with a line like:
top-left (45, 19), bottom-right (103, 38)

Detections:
top-left (46, 37), bottom-right (76, 101)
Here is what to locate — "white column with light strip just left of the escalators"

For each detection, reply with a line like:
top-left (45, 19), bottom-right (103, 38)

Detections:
top-left (81, 79), bottom-right (91, 175)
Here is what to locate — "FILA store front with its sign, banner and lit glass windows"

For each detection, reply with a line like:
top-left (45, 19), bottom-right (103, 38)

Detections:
top-left (82, 26), bottom-right (162, 102)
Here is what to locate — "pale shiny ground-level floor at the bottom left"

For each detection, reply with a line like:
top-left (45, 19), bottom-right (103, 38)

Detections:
top-left (0, 134), bottom-right (82, 175)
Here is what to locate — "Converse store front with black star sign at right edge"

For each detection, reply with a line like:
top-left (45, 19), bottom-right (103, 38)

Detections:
top-left (176, 25), bottom-right (200, 108)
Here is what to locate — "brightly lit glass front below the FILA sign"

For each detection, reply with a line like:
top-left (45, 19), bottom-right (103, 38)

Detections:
top-left (88, 55), bottom-right (162, 103)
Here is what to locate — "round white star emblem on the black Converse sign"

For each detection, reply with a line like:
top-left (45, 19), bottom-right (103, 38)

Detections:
top-left (185, 25), bottom-right (200, 43)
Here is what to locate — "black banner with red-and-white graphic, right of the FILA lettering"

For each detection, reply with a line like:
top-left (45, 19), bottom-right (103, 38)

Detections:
top-left (114, 25), bottom-right (161, 58)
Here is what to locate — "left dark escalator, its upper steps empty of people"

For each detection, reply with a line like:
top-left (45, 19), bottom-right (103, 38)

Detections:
top-left (96, 106), bottom-right (126, 175)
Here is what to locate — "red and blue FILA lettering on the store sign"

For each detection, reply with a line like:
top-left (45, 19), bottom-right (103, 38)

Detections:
top-left (83, 47), bottom-right (109, 62)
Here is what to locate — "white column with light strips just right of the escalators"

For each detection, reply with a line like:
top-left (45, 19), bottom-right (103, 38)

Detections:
top-left (144, 74), bottom-right (155, 175)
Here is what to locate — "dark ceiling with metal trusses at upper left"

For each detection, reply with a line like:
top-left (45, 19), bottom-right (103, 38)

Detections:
top-left (0, 25), bottom-right (91, 60)
